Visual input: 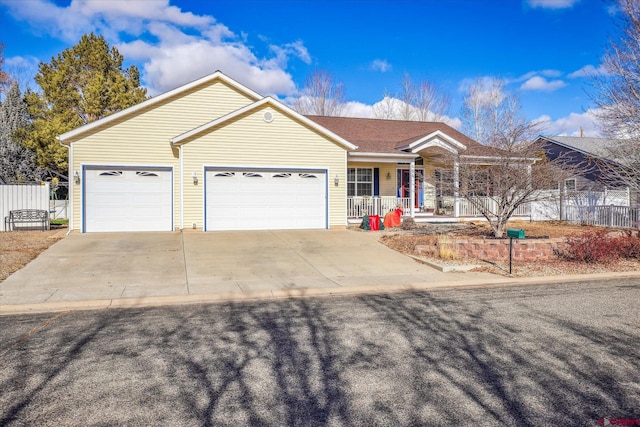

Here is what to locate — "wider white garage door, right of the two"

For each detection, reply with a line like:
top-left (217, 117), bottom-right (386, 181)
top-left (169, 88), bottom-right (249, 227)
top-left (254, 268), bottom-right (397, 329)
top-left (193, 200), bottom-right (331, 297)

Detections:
top-left (206, 170), bottom-right (327, 230)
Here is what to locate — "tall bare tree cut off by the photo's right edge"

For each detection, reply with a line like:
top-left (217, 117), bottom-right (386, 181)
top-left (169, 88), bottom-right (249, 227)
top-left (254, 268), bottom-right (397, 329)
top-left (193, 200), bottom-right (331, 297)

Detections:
top-left (592, 0), bottom-right (640, 196)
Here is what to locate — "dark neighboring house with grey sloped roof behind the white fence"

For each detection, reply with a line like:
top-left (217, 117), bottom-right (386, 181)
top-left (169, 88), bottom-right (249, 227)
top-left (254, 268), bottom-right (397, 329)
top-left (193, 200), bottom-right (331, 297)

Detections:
top-left (535, 136), bottom-right (631, 205)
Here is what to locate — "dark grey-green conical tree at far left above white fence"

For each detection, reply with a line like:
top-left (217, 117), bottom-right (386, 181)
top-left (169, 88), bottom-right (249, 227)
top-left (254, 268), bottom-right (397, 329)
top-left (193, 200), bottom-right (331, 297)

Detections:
top-left (0, 82), bottom-right (42, 183)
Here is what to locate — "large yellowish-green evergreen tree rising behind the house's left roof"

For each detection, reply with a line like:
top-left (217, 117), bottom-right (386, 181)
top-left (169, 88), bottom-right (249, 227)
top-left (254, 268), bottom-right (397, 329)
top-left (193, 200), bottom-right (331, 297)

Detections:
top-left (25, 33), bottom-right (147, 174)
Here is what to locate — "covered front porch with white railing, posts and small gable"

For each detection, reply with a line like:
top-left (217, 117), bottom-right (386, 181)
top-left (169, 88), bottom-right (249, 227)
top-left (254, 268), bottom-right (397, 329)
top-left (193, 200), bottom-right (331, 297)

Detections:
top-left (347, 136), bottom-right (531, 223)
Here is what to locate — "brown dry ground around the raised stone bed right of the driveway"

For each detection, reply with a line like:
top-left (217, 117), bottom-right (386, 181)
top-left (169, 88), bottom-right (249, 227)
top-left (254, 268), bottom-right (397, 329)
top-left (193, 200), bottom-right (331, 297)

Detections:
top-left (381, 221), bottom-right (640, 277)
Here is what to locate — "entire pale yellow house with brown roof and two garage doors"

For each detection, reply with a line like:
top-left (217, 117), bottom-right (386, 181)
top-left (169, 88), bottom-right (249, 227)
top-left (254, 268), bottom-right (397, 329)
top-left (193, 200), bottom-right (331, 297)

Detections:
top-left (59, 72), bottom-right (510, 232)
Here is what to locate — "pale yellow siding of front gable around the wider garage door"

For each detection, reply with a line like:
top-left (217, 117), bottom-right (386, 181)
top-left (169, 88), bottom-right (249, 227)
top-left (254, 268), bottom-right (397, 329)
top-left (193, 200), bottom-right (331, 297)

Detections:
top-left (183, 106), bottom-right (346, 228)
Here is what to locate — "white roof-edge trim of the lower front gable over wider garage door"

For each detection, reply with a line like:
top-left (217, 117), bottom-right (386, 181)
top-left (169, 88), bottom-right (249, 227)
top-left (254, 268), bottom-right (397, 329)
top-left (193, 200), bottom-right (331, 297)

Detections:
top-left (170, 96), bottom-right (358, 150)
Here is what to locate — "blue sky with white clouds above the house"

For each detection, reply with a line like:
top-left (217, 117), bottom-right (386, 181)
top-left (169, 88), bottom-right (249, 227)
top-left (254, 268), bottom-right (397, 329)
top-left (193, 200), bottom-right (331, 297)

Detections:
top-left (0, 0), bottom-right (616, 136)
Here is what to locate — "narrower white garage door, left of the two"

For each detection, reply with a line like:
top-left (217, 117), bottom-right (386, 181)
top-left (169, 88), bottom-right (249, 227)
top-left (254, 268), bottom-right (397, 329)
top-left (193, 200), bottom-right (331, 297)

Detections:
top-left (84, 166), bottom-right (173, 232)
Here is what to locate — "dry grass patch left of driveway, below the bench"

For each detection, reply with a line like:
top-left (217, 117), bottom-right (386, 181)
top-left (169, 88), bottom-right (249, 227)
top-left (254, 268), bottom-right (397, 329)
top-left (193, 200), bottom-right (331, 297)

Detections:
top-left (0, 230), bottom-right (64, 282)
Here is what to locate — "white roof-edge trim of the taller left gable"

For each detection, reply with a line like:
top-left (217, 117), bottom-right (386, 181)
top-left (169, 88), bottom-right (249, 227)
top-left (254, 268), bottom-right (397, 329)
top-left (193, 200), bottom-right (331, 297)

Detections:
top-left (57, 71), bottom-right (262, 145)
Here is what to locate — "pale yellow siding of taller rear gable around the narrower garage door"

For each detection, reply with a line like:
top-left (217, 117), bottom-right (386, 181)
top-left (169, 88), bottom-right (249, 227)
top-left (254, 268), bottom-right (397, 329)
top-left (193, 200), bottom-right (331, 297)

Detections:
top-left (71, 81), bottom-right (254, 229)
